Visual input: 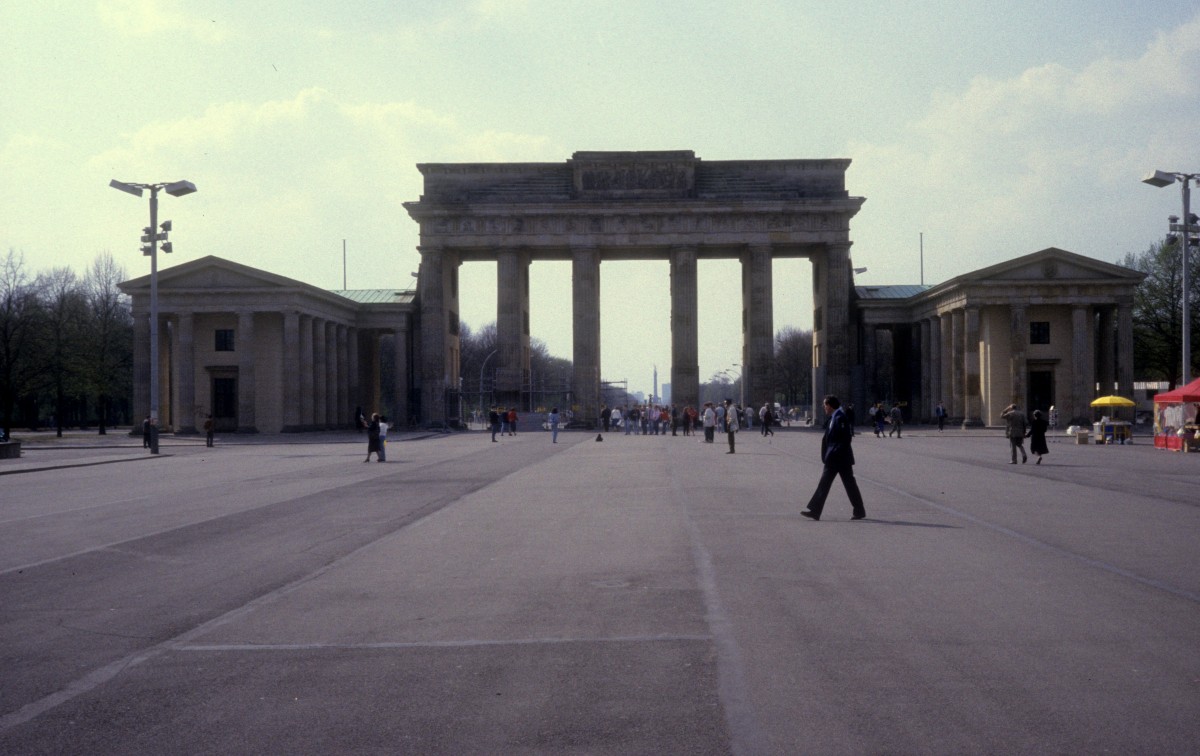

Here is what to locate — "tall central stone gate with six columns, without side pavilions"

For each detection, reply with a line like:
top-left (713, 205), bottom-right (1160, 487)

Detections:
top-left (404, 150), bottom-right (864, 422)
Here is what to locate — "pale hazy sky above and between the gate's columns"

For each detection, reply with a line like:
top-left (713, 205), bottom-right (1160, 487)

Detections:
top-left (0, 0), bottom-right (1200, 392)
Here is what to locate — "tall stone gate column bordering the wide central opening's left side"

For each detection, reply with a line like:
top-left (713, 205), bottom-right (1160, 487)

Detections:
top-left (571, 247), bottom-right (600, 428)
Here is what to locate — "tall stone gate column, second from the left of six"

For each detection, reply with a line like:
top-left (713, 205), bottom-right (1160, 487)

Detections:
top-left (496, 250), bottom-right (529, 406)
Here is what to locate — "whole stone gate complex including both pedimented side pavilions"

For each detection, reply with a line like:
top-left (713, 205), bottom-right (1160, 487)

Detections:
top-left (121, 151), bottom-right (1141, 432)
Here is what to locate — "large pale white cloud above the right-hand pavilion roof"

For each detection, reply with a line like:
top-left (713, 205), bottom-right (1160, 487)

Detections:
top-left (847, 11), bottom-right (1200, 283)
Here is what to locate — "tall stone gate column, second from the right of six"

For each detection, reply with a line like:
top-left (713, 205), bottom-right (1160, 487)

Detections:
top-left (742, 245), bottom-right (772, 407)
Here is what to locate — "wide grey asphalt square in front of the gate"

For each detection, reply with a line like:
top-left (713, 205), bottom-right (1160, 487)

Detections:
top-left (0, 426), bottom-right (1200, 754)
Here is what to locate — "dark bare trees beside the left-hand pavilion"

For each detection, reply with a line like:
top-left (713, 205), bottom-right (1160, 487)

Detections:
top-left (0, 250), bottom-right (133, 438)
